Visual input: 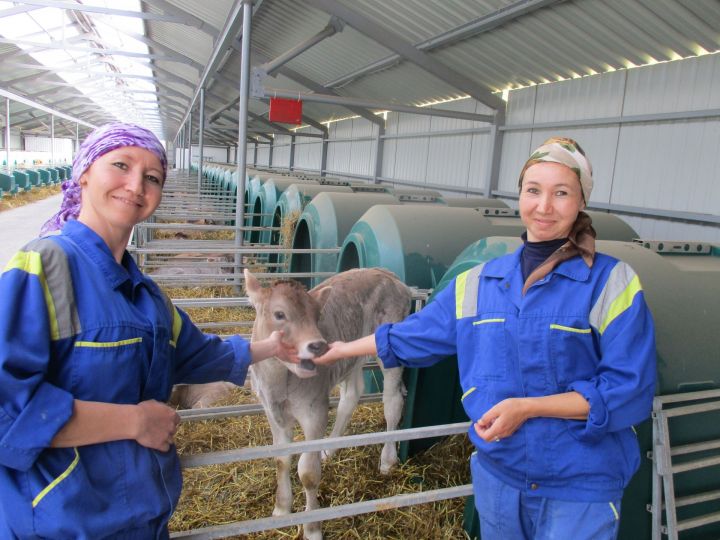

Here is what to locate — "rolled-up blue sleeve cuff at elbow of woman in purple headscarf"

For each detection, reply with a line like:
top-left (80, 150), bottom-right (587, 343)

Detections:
top-left (0, 383), bottom-right (75, 471)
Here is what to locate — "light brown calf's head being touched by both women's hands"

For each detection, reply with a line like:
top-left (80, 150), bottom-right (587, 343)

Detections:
top-left (245, 269), bottom-right (331, 378)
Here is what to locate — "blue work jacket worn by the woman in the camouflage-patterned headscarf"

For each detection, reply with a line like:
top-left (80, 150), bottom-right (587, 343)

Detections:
top-left (375, 247), bottom-right (656, 502)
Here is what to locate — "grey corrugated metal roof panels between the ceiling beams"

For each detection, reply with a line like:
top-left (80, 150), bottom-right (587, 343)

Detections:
top-left (0, 0), bottom-right (720, 138)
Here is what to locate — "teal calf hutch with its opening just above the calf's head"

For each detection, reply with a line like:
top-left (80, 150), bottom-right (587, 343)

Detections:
top-left (290, 192), bottom-right (399, 288)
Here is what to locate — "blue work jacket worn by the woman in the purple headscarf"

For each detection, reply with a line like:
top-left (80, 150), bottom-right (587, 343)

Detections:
top-left (0, 221), bottom-right (250, 540)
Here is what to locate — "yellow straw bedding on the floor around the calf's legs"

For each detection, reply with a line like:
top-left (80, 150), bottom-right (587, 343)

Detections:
top-left (170, 388), bottom-right (471, 540)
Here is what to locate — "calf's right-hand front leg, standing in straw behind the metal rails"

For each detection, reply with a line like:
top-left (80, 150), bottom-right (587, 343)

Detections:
top-left (297, 402), bottom-right (328, 540)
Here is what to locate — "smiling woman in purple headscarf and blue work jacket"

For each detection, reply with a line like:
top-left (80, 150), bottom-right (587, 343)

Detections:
top-left (0, 123), bottom-right (297, 539)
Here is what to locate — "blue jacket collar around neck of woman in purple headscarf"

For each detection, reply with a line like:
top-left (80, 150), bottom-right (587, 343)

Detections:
top-left (62, 220), bottom-right (146, 289)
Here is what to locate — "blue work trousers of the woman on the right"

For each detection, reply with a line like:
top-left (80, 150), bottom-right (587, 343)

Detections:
top-left (470, 455), bottom-right (620, 540)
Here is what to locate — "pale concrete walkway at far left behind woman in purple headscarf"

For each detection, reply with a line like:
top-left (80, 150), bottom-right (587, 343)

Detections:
top-left (0, 193), bottom-right (62, 271)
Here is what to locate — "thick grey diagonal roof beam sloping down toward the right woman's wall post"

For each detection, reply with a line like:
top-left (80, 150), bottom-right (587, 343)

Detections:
top-left (305, 0), bottom-right (505, 111)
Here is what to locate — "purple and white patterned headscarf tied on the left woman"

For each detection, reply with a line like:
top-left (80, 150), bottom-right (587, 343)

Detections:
top-left (40, 122), bottom-right (167, 236)
